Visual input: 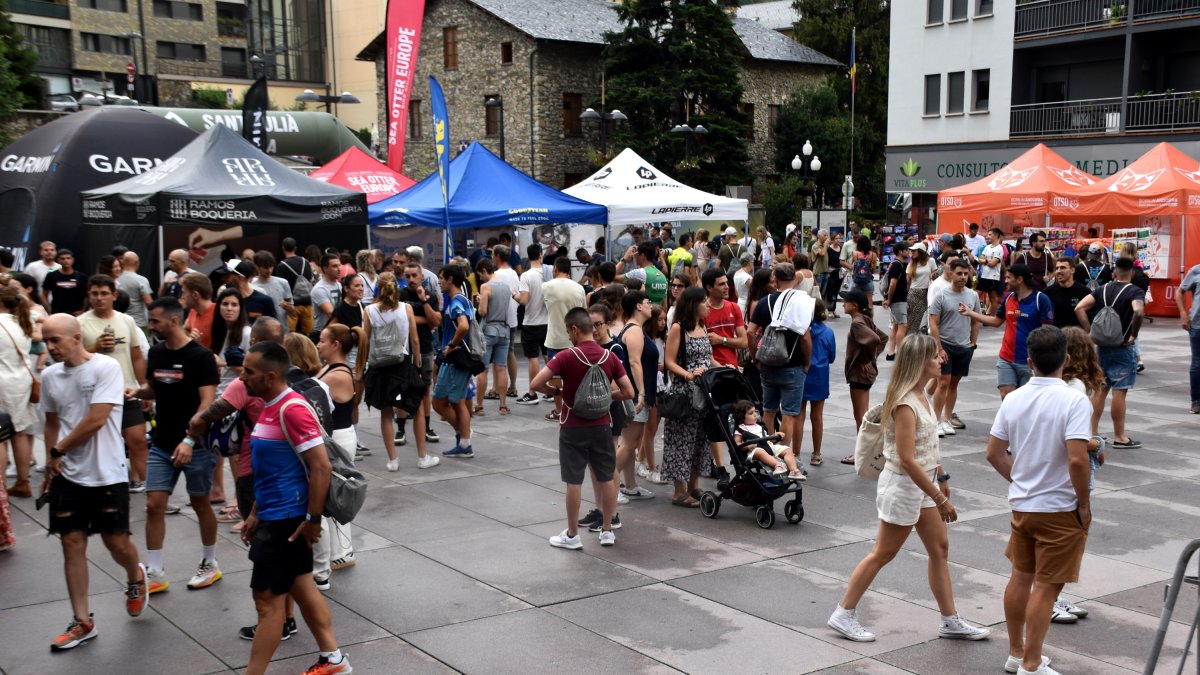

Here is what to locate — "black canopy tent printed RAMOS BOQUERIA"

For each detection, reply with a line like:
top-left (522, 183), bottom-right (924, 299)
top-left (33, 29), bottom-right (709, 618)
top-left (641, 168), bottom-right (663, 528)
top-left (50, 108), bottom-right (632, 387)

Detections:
top-left (82, 125), bottom-right (367, 271)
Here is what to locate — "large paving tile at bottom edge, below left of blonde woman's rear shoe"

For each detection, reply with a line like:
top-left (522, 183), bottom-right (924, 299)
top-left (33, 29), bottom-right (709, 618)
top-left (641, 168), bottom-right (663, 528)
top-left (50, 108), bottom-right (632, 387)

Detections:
top-left (547, 585), bottom-right (856, 673)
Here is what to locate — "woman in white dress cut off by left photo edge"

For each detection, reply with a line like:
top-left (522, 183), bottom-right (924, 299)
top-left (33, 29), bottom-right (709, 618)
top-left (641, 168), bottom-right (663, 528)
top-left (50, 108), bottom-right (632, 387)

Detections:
top-left (0, 285), bottom-right (40, 498)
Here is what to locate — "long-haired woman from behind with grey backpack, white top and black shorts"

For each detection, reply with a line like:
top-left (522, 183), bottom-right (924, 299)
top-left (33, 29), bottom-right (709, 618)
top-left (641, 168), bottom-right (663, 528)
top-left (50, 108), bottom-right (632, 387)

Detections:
top-left (355, 273), bottom-right (429, 471)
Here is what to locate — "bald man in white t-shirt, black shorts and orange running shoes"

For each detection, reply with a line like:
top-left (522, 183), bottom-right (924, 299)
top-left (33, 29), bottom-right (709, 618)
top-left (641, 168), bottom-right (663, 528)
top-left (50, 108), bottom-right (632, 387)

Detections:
top-left (41, 313), bottom-right (150, 651)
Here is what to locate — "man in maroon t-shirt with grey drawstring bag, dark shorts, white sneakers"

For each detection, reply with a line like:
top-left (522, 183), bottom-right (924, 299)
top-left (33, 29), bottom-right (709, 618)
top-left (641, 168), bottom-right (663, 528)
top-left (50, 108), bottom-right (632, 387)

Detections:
top-left (530, 307), bottom-right (634, 550)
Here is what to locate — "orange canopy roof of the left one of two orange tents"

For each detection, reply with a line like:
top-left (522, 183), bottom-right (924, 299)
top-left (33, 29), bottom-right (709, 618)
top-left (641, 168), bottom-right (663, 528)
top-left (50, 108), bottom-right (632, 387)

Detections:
top-left (937, 143), bottom-right (1097, 216)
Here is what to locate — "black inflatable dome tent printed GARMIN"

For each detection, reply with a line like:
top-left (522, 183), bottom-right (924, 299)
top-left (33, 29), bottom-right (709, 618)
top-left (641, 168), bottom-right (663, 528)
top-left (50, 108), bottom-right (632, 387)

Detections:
top-left (0, 106), bottom-right (197, 273)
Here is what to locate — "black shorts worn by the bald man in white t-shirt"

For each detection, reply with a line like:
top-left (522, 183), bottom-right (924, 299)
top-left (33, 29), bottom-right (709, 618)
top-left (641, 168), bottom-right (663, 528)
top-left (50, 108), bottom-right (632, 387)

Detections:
top-left (47, 476), bottom-right (130, 534)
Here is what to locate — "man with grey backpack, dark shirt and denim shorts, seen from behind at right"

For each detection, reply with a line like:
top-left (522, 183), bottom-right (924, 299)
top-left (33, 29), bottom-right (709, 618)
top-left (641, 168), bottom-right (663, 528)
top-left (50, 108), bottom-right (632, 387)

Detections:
top-left (1075, 257), bottom-right (1146, 449)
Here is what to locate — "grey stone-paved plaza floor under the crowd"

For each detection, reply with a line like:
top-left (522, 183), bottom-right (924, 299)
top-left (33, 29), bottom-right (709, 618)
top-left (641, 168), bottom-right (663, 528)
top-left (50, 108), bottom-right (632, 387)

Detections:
top-left (0, 312), bottom-right (1200, 675)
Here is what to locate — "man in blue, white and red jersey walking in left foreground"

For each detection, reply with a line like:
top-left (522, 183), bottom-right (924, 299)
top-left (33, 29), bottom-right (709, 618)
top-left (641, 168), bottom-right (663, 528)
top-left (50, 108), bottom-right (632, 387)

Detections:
top-left (241, 342), bottom-right (353, 675)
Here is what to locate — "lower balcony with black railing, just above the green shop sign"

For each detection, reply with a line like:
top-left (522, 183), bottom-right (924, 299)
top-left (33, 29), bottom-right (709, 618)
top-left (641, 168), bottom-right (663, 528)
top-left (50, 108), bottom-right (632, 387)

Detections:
top-left (1009, 91), bottom-right (1200, 138)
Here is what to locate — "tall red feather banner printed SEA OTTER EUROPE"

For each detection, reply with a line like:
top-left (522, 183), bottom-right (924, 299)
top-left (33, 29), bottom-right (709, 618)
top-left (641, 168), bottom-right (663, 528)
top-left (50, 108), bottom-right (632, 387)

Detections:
top-left (386, 0), bottom-right (425, 173)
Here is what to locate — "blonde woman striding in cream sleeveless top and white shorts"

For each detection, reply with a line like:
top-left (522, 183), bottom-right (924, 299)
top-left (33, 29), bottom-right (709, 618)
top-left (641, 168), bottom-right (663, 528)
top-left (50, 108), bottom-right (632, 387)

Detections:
top-left (829, 335), bottom-right (990, 643)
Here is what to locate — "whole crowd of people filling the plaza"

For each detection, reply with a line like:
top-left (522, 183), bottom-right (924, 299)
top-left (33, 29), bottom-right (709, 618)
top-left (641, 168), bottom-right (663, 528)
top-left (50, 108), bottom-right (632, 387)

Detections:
top-left (0, 223), bottom-right (1200, 675)
